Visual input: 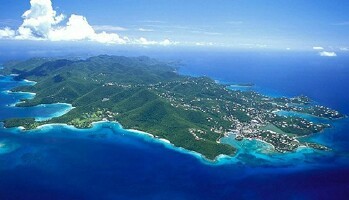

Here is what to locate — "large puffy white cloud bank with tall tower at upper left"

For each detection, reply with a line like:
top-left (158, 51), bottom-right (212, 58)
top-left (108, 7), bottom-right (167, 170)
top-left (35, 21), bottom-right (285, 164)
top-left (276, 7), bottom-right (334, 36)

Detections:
top-left (0, 0), bottom-right (176, 46)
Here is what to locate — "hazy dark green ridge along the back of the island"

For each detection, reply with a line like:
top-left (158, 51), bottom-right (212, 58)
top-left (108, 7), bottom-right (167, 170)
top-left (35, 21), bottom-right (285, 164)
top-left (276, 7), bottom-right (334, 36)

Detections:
top-left (5, 55), bottom-right (178, 84)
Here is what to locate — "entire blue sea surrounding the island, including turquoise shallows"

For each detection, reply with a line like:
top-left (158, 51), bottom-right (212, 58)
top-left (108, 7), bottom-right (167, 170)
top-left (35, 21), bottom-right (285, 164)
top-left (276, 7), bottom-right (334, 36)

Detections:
top-left (0, 52), bottom-right (349, 200)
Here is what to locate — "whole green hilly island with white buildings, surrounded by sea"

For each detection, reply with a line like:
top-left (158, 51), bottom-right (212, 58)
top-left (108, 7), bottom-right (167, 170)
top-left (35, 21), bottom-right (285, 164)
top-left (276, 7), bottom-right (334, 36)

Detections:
top-left (0, 55), bottom-right (345, 160)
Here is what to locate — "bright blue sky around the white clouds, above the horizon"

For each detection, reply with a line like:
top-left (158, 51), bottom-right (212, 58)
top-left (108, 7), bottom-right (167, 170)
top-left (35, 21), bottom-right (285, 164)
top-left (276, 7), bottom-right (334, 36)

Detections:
top-left (0, 0), bottom-right (349, 52)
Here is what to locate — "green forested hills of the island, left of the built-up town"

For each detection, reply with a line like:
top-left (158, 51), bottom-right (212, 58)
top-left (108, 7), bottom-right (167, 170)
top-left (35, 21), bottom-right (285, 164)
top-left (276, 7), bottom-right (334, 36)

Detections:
top-left (3, 55), bottom-right (234, 159)
